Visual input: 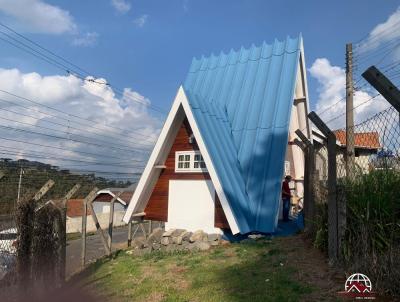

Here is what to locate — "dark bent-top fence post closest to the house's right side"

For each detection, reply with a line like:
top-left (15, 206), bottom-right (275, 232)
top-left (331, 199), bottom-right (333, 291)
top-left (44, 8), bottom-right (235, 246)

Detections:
top-left (295, 129), bottom-right (315, 232)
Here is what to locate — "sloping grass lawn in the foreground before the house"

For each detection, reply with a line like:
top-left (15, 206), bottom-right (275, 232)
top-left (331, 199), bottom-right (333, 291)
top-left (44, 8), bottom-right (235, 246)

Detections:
top-left (71, 237), bottom-right (336, 302)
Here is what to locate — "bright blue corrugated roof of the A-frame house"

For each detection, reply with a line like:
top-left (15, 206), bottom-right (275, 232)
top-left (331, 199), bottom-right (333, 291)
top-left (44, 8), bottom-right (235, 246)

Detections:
top-left (183, 37), bottom-right (302, 233)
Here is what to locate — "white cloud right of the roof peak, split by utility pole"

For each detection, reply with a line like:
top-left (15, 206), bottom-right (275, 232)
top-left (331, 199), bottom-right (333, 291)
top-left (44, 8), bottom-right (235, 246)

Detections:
top-left (309, 58), bottom-right (388, 129)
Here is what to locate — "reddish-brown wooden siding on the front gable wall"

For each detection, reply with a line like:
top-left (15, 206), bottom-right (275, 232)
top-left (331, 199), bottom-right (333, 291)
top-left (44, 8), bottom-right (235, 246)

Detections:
top-left (144, 119), bottom-right (229, 228)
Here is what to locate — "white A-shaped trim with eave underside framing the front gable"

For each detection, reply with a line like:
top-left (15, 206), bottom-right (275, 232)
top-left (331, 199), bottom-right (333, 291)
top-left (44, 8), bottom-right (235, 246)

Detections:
top-left (123, 86), bottom-right (240, 234)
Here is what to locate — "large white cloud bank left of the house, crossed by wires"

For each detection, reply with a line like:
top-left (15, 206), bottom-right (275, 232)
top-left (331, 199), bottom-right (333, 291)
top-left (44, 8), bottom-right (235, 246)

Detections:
top-left (0, 69), bottom-right (161, 177)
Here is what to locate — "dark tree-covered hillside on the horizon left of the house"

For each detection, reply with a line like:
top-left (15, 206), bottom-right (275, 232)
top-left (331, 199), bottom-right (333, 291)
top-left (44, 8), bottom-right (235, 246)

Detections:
top-left (0, 158), bottom-right (135, 215)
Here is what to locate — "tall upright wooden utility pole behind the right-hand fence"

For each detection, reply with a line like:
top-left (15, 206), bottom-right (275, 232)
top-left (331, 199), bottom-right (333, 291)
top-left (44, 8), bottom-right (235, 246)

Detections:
top-left (345, 43), bottom-right (354, 178)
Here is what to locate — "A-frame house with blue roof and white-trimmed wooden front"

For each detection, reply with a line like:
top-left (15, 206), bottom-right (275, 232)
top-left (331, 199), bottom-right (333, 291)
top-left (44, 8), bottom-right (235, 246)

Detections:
top-left (124, 37), bottom-right (311, 234)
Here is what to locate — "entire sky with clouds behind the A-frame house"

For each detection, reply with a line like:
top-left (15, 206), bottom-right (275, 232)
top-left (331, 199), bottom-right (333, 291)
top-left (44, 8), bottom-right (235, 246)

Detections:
top-left (0, 0), bottom-right (400, 178)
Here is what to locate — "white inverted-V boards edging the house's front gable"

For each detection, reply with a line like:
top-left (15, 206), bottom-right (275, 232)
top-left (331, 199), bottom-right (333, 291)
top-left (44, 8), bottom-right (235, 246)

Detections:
top-left (123, 86), bottom-right (240, 234)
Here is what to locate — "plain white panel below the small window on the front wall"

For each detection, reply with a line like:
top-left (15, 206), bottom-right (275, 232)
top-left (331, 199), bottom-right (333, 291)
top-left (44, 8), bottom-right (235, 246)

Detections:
top-left (165, 180), bottom-right (221, 233)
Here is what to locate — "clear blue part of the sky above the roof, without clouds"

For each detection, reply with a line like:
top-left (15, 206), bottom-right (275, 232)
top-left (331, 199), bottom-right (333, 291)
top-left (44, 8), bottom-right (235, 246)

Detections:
top-left (0, 0), bottom-right (399, 109)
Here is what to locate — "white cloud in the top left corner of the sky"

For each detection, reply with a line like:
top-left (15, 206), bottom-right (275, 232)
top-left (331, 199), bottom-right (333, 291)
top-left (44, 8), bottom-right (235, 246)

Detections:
top-left (0, 0), bottom-right (77, 34)
